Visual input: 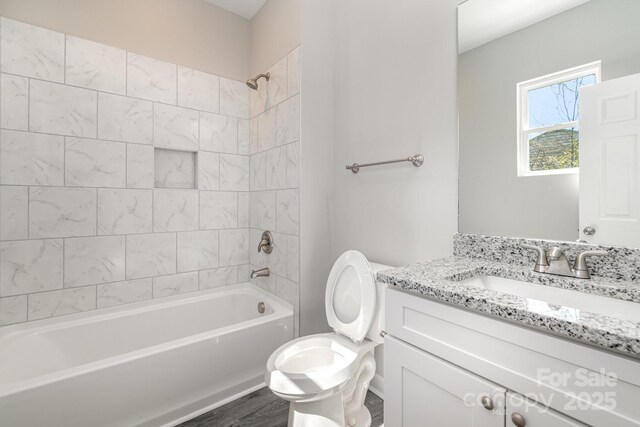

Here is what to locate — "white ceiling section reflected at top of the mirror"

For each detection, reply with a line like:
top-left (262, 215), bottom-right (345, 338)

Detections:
top-left (458, 0), bottom-right (589, 53)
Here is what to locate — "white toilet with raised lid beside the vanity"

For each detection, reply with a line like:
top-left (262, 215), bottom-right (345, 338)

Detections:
top-left (265, 251), bottom-right (391, 427)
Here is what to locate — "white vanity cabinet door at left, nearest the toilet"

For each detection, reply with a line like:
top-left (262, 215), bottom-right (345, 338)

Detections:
top-left (384, 335), bottom-right (506, 427)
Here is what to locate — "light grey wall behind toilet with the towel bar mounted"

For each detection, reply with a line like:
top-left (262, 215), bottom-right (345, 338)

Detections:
top-left (330, 0), bottom-right (458, 265)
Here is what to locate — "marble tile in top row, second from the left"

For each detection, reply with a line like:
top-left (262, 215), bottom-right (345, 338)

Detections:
top-left (65, 36), bottom-right (127, 95)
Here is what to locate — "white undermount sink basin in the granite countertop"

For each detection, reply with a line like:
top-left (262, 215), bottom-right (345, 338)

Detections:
top-left (460, 275), bottom-right (640, 322)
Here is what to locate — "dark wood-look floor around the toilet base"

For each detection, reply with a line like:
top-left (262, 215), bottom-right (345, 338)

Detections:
top-left (180, 387), bottom-right (384, 427)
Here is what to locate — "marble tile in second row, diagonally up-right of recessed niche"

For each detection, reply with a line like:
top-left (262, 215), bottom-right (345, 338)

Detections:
top-left (200, 113), bottom-right (238, 154)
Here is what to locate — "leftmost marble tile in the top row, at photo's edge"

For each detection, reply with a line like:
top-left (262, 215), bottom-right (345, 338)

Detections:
top-left (0, 18), bottom-right (64, 82)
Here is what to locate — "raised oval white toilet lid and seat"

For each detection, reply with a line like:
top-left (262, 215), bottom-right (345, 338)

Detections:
top-left (325, 251), bottom-right (376, 342)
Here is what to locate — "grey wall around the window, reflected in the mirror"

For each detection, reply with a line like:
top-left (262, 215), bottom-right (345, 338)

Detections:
top-left (459, 0), bottom-right (640, 240)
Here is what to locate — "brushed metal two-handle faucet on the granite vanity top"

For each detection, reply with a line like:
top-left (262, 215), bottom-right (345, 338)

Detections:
top-left (520, 243), bottom-right (609, 279)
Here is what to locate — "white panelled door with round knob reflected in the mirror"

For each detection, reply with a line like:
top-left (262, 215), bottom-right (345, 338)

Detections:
top-left (580, 74), bottom-right (640, 248)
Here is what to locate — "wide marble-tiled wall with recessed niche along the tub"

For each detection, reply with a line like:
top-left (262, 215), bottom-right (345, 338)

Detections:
top-left (0, 18), bottom-right (258, 325)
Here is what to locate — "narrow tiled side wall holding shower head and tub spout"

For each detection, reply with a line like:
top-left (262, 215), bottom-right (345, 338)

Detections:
top-left (249, 47), bottom-right (300, 336)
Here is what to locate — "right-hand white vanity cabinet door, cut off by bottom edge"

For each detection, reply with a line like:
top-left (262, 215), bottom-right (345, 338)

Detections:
top-left (507, 392), bottom-right (587, 427)
